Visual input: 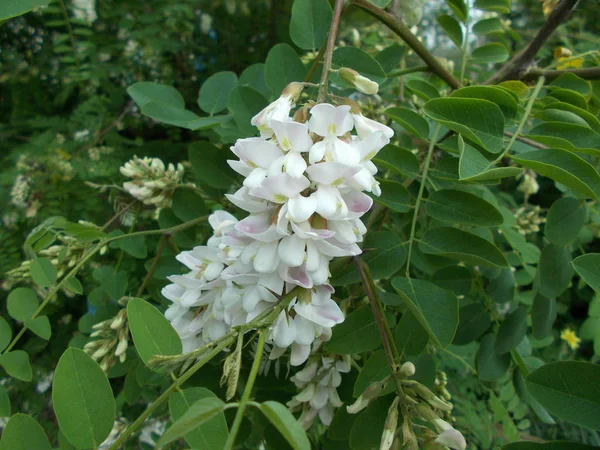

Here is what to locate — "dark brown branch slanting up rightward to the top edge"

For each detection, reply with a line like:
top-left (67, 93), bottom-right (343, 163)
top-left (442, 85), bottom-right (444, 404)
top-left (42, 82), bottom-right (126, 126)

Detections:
top-left (483, 0), bottom-right (578, 84)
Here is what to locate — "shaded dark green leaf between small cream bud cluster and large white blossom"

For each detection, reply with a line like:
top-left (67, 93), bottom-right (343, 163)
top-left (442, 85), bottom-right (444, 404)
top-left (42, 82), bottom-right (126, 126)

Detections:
top-left (189, 141), bottom-right (235, 189)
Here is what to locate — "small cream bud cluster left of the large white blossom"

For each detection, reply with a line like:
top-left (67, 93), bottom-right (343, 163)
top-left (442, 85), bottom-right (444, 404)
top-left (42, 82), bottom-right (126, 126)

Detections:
top-left (120, 156), bottom-right (184, 208)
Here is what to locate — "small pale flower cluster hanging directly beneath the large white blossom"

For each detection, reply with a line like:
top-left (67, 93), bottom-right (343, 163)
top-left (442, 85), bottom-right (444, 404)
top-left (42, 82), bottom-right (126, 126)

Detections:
top-left (287, 355), bottom-right (350, 429)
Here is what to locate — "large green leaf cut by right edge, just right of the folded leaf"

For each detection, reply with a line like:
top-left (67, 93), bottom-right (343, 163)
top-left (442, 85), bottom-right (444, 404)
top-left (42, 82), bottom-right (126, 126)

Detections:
top-left (512, 149), bottom-right (600, 200)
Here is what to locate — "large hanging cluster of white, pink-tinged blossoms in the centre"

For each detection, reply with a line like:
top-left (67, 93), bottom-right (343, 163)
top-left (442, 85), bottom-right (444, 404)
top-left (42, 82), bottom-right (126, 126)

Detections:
top-left (163, 83), bottom-right (393, 365)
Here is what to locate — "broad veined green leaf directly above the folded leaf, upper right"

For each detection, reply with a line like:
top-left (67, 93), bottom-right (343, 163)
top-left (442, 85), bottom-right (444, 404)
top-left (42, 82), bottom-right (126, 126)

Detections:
top-left (425, 97), bottom-right (504, 153)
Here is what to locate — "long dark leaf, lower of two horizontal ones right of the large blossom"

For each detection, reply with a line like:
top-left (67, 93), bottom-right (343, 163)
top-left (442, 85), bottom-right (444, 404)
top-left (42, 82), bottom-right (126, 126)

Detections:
top-left (419, 227), bottom-right (508, 267)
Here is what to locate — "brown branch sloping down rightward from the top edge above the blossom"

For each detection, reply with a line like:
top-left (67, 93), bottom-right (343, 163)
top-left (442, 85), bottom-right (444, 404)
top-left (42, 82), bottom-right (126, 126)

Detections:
top-left (352, 0), bottom-right (462, 89)
